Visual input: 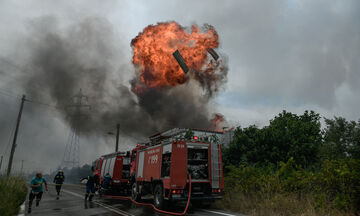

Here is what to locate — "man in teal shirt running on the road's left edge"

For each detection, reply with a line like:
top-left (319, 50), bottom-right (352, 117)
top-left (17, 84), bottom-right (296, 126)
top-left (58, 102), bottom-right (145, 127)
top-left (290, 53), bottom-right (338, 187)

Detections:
top-left (28, 172), bottom-right (48, 213)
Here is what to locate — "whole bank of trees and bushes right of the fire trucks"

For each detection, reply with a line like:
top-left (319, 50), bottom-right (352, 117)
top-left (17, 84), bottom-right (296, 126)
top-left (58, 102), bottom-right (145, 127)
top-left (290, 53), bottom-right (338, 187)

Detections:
top-left (218, 111), bottom-right (360, 215)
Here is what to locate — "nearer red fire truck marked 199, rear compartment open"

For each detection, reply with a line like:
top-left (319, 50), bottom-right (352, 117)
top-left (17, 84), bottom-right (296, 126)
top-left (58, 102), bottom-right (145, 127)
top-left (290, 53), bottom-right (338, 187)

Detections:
top-left (130, 128), bottom-right (224, 208)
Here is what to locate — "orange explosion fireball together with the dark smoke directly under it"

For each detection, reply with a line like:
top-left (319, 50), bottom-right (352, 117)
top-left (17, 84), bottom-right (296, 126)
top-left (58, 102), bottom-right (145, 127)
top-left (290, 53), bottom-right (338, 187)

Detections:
top-left (130, 21), bottom-right (227, 131)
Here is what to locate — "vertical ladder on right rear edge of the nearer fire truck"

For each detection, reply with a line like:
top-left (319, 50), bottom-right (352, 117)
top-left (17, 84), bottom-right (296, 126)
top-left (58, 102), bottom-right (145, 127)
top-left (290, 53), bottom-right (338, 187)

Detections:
top-left (211, 142), bottom-right (222, 188)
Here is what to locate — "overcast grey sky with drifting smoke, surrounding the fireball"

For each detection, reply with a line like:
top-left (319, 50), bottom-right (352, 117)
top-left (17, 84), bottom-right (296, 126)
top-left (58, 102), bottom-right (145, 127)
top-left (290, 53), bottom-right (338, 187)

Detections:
top-left (0, 0), bottom-right (360, 172)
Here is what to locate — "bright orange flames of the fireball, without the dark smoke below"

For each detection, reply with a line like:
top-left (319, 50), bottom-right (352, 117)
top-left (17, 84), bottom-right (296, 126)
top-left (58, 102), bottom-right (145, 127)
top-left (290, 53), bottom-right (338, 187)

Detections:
top-left (131, 22), bottom-right (219, 93)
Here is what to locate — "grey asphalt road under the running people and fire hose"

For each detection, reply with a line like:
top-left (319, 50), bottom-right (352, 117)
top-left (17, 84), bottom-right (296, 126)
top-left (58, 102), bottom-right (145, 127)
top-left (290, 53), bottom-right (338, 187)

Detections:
top-left (26, 184), bottom-right (243, 216)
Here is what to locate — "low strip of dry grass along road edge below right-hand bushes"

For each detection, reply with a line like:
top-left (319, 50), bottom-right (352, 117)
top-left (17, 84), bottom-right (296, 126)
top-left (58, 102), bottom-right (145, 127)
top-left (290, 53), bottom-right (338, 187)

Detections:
top-left (215, 194), bottom-right (354, 216)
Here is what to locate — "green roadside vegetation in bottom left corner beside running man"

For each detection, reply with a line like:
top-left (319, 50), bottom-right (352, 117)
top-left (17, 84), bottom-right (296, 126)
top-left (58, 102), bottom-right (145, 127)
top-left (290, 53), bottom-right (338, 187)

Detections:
top-left (0, 176), bottom-right (27, 216)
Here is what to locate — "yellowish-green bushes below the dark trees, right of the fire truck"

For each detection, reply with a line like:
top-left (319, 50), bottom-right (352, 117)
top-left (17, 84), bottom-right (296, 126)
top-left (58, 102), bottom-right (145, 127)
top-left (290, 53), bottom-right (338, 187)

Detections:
top-left (222, 158), bottom-right (360, 215)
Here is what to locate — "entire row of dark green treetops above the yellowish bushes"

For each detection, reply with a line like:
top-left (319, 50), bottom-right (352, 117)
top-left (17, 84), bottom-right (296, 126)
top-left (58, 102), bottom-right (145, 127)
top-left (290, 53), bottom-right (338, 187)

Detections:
top-left (224, 111), bottom-right (360, 168)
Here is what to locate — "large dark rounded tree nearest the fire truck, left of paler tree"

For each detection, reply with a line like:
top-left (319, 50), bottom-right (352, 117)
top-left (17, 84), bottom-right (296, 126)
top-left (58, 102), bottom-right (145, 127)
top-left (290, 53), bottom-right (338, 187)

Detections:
top-left (224, 111), bottom-right (322, 166)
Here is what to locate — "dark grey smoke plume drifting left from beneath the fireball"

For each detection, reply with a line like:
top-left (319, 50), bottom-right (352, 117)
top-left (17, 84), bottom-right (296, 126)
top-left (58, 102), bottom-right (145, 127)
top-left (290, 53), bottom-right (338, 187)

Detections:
top-left (23, 17), bottom-right (227, 136)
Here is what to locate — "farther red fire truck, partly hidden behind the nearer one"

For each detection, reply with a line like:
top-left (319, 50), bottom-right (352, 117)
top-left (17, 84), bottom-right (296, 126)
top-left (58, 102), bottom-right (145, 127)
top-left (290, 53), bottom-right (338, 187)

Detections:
top-left (93, 152), bottom-right (130, 192)
